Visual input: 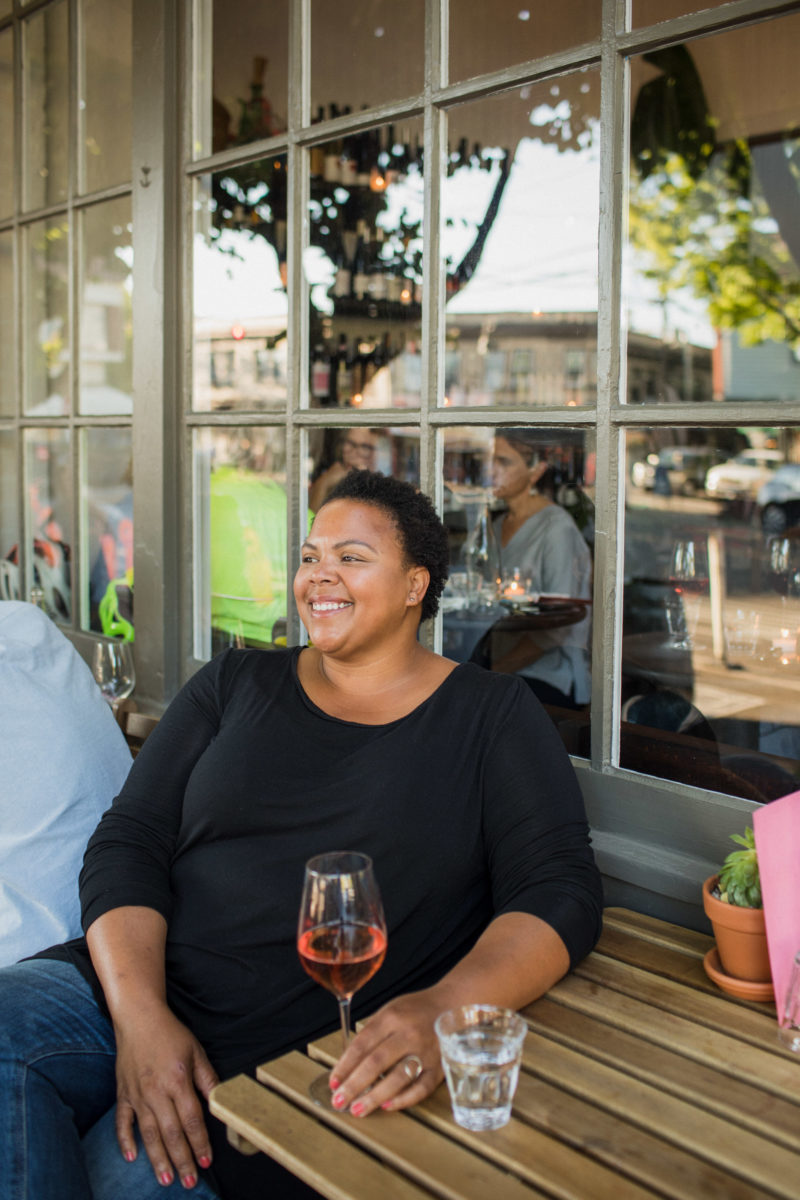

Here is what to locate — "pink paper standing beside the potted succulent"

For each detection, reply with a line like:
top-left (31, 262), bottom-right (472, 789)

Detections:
top-left (753, 792), bottom-right (800, 1025)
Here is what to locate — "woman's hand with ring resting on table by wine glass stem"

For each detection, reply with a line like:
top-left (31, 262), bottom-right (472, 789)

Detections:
top-left (331, 988), bottom-right (446, 1117)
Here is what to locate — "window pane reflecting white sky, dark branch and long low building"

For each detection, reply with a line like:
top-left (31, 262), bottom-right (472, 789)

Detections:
top-left (443, 79), bottom-right (600, 408)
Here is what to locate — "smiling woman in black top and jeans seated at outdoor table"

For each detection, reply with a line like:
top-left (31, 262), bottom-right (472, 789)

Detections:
top-left (0, 470), bottom-right (602, 1200)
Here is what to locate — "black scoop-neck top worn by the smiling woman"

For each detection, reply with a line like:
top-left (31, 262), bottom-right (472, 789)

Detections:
top-left (49, 649), bottom-right (602, 1078)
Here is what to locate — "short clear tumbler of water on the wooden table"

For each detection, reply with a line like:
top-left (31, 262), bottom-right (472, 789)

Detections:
top-left (434, 1004), bottom-right (528, 1129)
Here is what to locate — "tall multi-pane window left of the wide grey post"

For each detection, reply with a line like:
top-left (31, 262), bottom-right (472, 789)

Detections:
top-left (0, 0), bottom-right (133, 636)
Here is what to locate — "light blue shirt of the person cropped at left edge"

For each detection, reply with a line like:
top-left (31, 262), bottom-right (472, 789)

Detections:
top-left (0, 600), bottom-right (131, 966)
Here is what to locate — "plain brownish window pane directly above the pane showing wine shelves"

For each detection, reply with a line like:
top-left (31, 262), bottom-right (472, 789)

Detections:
top-left (311, 0), bottom-right (425, 118)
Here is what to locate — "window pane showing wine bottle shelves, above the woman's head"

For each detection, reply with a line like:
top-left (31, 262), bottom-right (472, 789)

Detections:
top-left (305, 121), bottom-right (423, 408)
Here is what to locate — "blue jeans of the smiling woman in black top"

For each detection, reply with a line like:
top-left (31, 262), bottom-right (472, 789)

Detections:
top-left (0, 959), bottom-right (217, 1200)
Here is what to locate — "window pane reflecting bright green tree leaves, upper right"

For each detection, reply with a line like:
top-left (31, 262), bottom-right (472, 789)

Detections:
top-left (625, 14), bottom-right (800, 403)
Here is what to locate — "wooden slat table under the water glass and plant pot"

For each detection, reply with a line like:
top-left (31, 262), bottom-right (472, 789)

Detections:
top-left (211, 908), bottom-right (800, 1200)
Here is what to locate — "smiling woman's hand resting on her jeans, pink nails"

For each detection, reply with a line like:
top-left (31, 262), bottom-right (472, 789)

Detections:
top-left (114, 1004), bottom-right (218, 1188)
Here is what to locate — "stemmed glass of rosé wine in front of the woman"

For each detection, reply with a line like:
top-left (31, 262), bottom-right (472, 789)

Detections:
top-left (297, 851), bottom-right (386, 1105)
